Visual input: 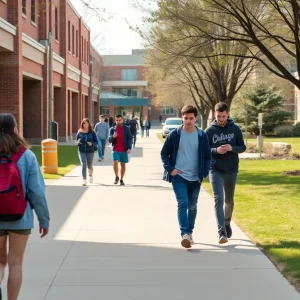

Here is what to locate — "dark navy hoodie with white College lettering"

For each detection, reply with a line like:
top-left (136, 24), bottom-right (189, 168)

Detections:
top-left (205, 119), bottom-right (246, 174)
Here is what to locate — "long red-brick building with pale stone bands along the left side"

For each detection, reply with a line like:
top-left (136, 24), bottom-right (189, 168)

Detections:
top-left (0, 0), bottom-right (101, 142)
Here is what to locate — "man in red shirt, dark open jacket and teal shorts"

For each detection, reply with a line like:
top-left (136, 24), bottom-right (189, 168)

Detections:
top-left (109, 115), bottom-right (132, 185)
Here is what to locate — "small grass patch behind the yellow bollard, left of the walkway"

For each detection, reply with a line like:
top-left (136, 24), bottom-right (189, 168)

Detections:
top-left (30, 146), bottom-right (79, 179)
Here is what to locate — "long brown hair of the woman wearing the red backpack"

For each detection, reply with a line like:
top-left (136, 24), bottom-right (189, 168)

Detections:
top-left (0, 113), bottom-right (29, 155)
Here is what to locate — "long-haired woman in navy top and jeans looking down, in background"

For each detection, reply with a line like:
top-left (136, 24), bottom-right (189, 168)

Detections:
top-left (76, 118), bottom-right (98, 186)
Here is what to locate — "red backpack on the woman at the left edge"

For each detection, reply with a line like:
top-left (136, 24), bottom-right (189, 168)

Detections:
top-left (0, 147), bottom-right (27, 222)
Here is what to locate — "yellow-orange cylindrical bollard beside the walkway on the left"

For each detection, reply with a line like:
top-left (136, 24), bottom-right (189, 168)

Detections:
top-left (42, 139), bottom-right (58, 174)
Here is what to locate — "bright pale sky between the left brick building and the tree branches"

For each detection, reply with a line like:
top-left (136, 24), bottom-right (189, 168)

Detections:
top-left (71, 0), bottom-right (142, 55)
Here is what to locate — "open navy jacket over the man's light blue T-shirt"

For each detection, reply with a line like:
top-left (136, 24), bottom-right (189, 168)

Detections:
top-left (160, 127), bottom-right (211, 182)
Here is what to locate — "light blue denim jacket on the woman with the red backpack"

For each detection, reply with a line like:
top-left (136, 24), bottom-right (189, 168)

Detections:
top-left (0, 149), bottom-right (50, 230)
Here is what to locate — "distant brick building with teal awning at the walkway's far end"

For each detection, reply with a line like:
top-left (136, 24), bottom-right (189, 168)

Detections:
top-left (100, 50), bottom-right (160, 121)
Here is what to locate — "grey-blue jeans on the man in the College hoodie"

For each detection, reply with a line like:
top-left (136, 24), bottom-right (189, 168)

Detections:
top-left (209, 170), bottom-right (237, 235)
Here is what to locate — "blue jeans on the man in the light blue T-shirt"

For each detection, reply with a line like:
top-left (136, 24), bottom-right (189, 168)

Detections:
top-left (172, 175), bottom-right (201, 236)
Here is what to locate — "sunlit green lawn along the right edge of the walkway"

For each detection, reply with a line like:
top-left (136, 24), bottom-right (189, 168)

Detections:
top-left (157, 134), bottom-right (300, 292)
